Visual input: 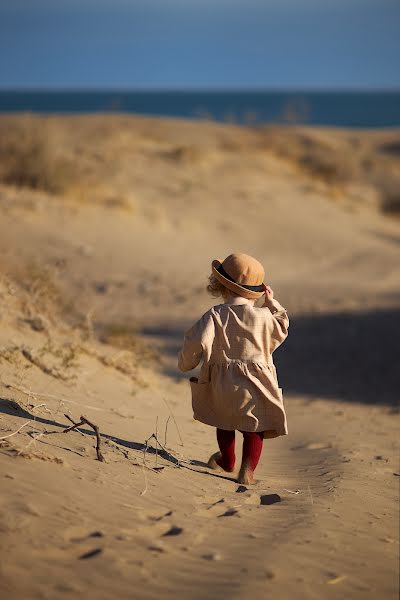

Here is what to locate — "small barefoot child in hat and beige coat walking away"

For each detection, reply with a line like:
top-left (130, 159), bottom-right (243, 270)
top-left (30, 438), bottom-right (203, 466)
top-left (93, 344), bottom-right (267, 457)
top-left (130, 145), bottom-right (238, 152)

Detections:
top-left (178, 254), bottom-right (289, 485)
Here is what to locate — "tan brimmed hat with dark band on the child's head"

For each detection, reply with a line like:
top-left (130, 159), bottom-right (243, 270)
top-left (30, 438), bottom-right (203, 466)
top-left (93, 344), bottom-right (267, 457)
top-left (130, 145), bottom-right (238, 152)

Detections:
top-left (211, 253), bottom-right (265, 299)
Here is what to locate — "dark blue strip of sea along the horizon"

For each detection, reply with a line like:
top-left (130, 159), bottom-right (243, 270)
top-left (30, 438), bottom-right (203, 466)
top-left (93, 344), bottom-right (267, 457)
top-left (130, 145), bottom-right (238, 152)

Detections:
top-left (0, 91), bottom-right (400, 127)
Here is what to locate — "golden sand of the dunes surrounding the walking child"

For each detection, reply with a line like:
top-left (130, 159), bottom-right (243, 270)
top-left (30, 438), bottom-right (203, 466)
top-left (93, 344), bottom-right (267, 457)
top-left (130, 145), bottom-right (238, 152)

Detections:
top-left (0, 116), bottom-right (400, 599)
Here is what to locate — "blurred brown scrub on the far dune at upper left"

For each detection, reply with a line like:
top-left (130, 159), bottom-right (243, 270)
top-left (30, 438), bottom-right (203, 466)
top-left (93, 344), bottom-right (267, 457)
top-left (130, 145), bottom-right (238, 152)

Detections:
top-left (0, 114), bottom-right (131, 208)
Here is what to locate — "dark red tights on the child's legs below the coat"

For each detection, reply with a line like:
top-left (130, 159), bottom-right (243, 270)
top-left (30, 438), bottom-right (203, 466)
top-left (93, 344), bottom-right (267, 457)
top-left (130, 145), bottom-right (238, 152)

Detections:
top-left (216, 429), bottom-right (264, 471)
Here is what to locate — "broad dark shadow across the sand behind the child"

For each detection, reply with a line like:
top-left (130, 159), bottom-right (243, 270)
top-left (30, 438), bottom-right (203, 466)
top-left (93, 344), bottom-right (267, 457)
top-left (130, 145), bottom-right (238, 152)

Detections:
top-left (143, 309), bottom-right (400, 406)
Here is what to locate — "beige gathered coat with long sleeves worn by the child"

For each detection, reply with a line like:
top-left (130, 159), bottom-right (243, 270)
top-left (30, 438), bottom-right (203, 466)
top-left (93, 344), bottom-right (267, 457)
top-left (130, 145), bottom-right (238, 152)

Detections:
top-left (178, 300), bottom-right (289, 437)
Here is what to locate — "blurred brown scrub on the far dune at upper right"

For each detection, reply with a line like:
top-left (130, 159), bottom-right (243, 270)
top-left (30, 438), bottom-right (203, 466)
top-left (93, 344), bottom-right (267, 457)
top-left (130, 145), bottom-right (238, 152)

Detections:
top-left (263, 127), bottom-right (400, 215)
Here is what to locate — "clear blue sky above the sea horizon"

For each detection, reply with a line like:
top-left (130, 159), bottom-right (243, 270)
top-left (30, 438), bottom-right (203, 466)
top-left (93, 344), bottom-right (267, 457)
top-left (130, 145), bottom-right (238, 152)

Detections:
top-left (0, 0), bottom-right (400, 90)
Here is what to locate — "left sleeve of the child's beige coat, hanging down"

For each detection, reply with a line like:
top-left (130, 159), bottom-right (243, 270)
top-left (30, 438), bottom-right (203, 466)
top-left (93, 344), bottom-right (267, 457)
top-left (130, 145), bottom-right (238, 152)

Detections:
top-left (178, 312), bottom-right (214, 371)
